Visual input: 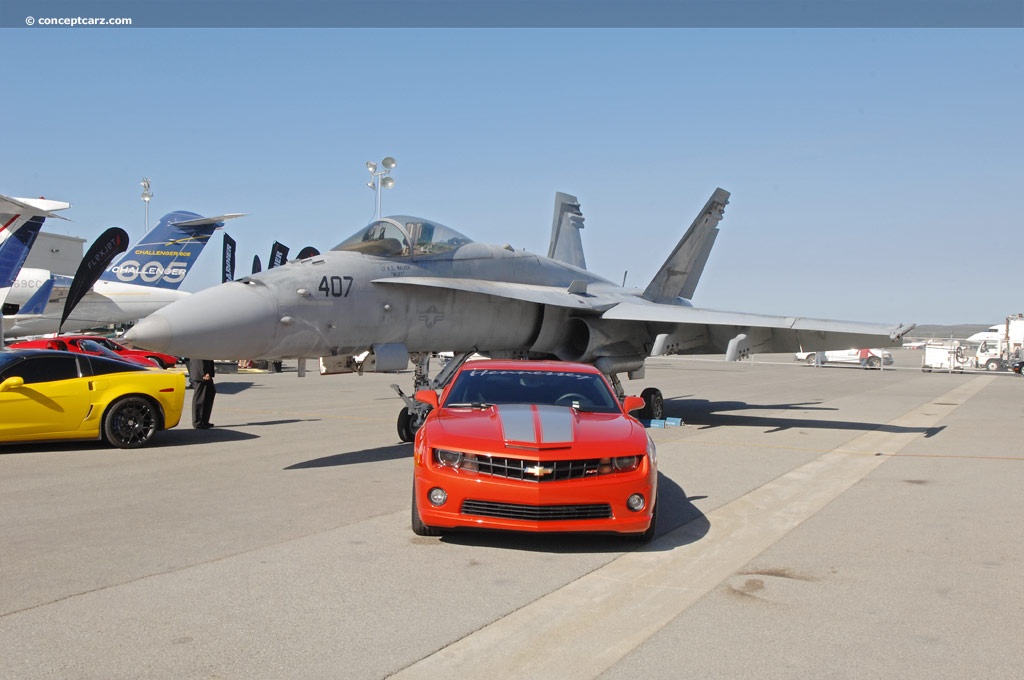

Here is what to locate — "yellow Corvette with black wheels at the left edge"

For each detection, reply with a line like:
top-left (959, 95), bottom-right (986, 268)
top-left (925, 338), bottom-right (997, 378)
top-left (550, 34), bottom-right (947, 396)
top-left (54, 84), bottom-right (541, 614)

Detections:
top-left (0, 349), bottom-right (185, 449)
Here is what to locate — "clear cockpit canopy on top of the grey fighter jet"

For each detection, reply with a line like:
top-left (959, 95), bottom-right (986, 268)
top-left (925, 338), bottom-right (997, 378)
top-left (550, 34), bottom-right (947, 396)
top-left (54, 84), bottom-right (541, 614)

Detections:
top-left (333, 215), bottom-right (472, 258)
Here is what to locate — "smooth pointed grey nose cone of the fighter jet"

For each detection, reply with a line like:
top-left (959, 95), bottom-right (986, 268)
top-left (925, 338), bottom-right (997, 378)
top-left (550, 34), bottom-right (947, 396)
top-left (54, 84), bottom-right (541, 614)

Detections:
top-left (125, 282), bottom-right (278, 358)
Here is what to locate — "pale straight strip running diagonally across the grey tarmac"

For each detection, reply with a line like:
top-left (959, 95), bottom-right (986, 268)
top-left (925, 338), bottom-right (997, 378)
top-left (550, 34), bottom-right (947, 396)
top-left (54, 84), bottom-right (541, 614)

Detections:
top-left (391, 376), bottom-right (993, 680)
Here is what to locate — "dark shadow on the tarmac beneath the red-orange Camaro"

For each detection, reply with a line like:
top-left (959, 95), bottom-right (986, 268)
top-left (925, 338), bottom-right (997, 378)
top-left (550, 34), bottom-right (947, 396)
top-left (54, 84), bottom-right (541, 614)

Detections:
top-left (440, 472), bottom-right (711, 553)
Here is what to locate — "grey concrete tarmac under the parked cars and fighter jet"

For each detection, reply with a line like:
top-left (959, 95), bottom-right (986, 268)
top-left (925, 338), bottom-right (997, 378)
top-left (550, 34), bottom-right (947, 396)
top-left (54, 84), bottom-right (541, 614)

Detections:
top-left (0, 350), bottom-right (1024, 680)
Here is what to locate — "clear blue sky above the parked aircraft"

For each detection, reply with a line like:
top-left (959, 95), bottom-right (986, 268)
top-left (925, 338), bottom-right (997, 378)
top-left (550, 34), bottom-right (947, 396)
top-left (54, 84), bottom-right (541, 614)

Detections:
top-left (0, 29), bottom-right (1024, 324)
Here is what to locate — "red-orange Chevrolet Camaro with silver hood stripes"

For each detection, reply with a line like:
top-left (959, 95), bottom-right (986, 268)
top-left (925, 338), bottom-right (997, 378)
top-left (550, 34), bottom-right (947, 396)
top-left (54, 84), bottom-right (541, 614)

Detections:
top-left (412, 360), bottom-right (657, 541)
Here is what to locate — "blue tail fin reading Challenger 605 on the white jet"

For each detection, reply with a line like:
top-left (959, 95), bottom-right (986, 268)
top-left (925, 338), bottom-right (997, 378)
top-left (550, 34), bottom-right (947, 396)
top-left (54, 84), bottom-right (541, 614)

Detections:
top-left (99, 210), bottom-right (242, 290)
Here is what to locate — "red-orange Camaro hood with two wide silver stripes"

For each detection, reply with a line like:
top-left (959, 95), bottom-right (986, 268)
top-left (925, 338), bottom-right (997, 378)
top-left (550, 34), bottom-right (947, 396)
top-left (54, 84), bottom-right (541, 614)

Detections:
top-left (425, 403), bottom-right (646, 458)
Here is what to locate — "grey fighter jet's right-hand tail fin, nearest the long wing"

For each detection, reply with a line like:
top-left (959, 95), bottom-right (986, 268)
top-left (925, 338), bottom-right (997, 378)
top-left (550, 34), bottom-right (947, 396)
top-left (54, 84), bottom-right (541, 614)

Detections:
top-left (643, 188), bottom-right (729, 302)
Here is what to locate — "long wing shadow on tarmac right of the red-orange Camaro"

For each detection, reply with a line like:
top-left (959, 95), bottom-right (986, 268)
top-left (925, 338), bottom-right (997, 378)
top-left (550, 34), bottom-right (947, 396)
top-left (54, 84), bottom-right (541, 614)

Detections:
top-left (665, 399), bottom-right (945, 437)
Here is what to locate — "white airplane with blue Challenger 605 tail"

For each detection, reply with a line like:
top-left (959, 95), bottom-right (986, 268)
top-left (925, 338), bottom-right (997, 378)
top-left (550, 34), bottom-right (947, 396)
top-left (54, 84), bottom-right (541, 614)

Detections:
top-left (3, 210), bottom-right (243, 337)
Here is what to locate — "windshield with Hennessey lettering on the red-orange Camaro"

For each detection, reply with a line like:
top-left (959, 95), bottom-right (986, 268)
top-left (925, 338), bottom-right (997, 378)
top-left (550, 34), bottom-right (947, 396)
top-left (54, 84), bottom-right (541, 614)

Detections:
top-left (443, 369), bottom-right (618, 413)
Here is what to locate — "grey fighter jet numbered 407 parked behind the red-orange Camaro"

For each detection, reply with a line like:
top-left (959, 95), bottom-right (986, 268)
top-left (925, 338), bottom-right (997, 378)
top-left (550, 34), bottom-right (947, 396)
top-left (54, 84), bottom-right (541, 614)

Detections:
top-left (126, 189), bottom-right (912, 440)
